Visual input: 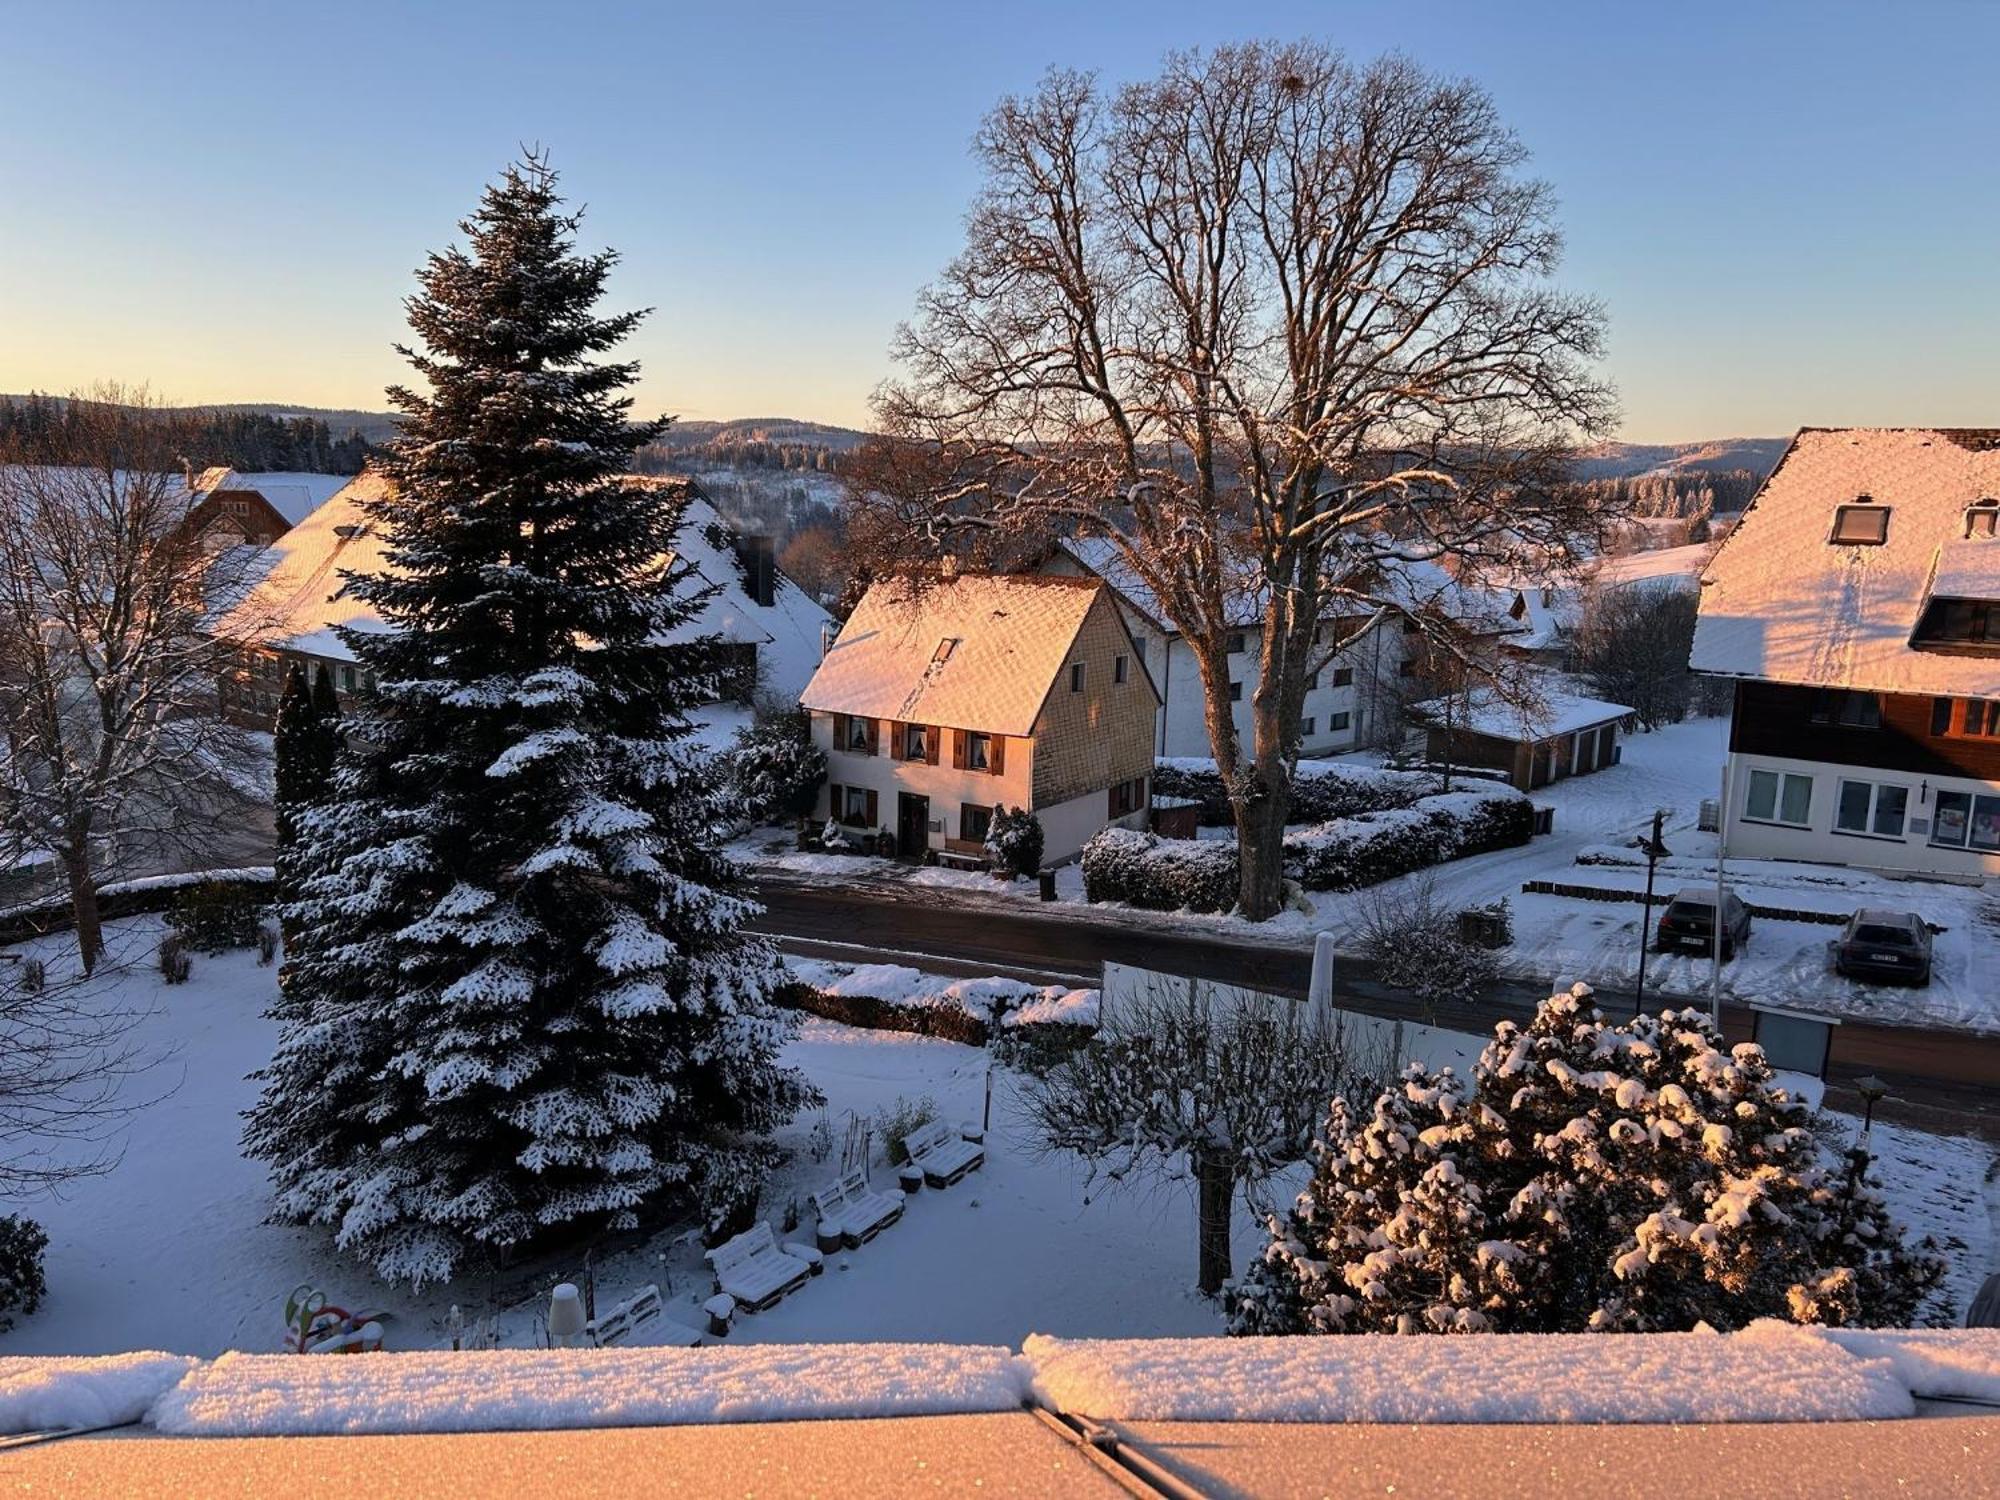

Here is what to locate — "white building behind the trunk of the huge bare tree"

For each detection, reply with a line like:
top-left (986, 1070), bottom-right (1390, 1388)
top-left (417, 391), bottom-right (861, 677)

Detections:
top-left (1042, 538), bottom-right (1524, 758)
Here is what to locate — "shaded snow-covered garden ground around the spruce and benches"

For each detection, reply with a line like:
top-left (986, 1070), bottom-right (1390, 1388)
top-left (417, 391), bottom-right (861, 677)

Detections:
top-left (0, 918), bottom-right (1994, 1356)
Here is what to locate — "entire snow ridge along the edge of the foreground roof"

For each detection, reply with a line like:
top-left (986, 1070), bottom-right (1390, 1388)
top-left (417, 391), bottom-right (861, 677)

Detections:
top-left (0, 1322), bottom-right (2000, 1438)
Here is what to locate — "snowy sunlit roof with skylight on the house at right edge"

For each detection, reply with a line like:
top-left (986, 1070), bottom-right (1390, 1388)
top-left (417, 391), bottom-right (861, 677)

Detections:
top-left (1690, 428), bottom-right (2000, 696)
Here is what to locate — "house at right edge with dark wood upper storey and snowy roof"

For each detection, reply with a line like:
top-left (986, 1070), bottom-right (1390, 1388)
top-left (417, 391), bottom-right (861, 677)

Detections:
top-left (1692, 428), bottom-right (2000, 878)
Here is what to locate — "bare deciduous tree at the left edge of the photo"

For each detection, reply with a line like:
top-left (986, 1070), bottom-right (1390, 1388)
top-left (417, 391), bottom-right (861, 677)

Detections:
top-left (0, 388), bottom-right (268, 972)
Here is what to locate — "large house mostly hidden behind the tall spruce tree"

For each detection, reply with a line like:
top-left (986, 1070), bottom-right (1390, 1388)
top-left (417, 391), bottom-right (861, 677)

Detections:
top-left (205, 472), bottom-right (832, 726)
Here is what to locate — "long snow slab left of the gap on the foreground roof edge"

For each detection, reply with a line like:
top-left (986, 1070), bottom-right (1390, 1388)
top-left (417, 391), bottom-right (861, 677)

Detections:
top-left (152, 1344), bottom-right (1026, 1438)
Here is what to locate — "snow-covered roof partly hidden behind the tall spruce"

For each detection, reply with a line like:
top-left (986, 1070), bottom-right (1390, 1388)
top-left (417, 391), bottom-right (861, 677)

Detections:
top-left (205, 474), bottom-right (832, 700)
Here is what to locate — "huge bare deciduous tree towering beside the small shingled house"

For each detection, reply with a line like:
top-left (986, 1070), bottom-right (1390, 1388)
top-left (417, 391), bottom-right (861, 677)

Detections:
top-left (876, 42), bottom-right (1614, 918)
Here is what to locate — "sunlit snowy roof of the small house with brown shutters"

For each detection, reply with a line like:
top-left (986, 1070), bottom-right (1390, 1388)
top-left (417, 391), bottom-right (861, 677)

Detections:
top-left (800, 574), bottom-right (1136, 734)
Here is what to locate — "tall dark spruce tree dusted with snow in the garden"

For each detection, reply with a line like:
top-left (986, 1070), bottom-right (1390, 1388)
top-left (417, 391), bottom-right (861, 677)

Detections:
top-left (246, 158), bottom-right (812, 1284)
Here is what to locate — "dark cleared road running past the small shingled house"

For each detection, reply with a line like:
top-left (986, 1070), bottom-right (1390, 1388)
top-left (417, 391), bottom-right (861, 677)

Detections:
top-left (756, 876), bottom-right (2000, 1140)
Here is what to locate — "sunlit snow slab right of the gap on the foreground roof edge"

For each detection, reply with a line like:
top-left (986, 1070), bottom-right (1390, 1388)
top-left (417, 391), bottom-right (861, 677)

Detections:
top-left (1022, 1322), bottom-right (1912, 1422)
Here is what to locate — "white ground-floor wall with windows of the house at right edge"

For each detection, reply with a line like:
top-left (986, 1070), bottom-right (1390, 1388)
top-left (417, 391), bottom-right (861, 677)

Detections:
top-left (1728, 754), bottom-right (2000, 880)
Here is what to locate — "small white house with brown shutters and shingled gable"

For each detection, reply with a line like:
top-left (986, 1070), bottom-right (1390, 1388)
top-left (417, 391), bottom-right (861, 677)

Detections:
top-left (800, 574), bottom-right (1160, 864)
